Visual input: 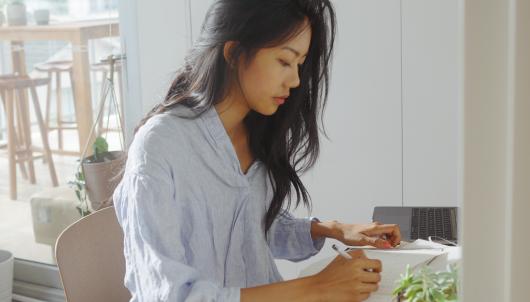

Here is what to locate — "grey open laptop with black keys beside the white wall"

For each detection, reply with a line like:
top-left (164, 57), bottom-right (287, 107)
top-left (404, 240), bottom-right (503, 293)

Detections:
top-left (372, 207), bottom-right (458, 244)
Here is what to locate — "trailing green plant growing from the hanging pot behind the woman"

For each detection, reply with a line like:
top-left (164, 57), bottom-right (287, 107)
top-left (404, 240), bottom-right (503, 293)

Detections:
top-left (68, 137), bottom-right (113, 217)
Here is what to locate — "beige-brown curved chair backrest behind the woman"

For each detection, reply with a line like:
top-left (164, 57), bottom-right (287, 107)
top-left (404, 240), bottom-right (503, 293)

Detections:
top-left (55, 207), bottom-right (131, 302)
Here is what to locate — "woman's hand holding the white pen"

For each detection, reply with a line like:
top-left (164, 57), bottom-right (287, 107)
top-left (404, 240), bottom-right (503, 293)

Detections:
top-left (312, 250), bottom-right (382, 302)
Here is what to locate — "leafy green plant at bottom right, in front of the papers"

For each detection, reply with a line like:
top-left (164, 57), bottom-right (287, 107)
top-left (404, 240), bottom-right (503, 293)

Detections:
top-left (392, 265), bottom-right (458, 302)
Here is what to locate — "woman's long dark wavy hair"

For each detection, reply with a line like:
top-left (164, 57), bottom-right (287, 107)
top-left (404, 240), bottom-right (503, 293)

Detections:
top-left (135, 0), bottom-right (335, 234)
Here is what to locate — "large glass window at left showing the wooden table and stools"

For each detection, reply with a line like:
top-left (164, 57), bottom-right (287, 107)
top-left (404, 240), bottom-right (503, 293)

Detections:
top-left (0, 0), bottom-right (124, 300)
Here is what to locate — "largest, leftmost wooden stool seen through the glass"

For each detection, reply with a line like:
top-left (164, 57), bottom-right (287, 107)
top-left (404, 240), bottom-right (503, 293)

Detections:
top-left (0, 76), bottom-right (58, 200)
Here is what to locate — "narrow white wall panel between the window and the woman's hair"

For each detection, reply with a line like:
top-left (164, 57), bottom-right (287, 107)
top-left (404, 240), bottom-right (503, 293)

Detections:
top-left (120, 0), bottom-right (191, 142)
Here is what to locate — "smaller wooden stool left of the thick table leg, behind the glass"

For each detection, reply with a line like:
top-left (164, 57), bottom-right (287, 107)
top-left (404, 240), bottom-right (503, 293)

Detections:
top-left (35, 61), bottom-right (81, 155)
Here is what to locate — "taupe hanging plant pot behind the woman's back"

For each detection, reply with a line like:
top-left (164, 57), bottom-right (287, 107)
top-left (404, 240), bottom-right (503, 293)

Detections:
top-left (82, 151), bottom-right (126, 211)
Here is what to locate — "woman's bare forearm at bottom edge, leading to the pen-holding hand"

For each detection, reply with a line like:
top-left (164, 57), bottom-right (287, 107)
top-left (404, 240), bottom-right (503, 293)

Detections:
top-left (241, 276), bottom-right (320, 302)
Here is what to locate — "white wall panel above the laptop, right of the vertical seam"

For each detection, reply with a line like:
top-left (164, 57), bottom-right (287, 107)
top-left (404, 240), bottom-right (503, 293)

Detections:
top-left (402, 0), bottom-right (459, 206)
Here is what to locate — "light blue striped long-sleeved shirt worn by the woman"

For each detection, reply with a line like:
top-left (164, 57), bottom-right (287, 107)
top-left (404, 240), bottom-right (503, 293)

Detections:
top-left (113, 105), bottom-right (324, 302)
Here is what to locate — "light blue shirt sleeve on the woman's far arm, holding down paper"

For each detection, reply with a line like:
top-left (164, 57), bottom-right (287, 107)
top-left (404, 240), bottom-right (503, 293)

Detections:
top-left (267, 210), bottom-right (326, 262)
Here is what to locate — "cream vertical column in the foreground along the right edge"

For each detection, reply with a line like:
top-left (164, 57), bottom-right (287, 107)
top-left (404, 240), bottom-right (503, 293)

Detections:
top-left (461, 0), bottom-right (530, 302)
